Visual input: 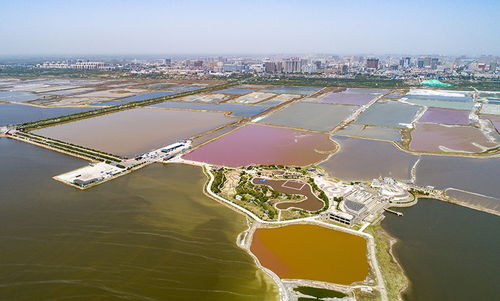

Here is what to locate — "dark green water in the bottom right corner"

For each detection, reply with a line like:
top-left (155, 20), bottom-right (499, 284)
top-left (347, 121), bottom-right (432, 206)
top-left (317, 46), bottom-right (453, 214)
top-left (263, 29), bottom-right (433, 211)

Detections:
top-left (382, 199), bottom-right (500, 301)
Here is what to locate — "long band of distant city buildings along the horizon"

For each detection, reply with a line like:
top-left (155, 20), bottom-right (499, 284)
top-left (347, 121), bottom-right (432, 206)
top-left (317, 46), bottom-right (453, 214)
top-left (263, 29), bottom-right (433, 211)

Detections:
top-left (29, 55), bottom-right (500, 79)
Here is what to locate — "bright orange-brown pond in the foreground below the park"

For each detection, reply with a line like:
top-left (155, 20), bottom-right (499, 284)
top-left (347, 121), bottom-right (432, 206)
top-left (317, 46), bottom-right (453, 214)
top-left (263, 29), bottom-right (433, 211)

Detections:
top-left (250, 225), bottom-right (369, 284)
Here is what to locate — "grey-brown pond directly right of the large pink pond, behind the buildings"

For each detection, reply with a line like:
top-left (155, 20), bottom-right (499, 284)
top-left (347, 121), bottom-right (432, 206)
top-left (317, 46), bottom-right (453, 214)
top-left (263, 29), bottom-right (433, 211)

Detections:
top-left (320, 136), bottom-right (418, 181)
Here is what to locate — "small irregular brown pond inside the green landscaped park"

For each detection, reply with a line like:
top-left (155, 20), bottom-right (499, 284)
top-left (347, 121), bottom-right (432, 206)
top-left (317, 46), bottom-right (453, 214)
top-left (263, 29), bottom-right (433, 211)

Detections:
top-left (252, 178), bottom-right (325, 211)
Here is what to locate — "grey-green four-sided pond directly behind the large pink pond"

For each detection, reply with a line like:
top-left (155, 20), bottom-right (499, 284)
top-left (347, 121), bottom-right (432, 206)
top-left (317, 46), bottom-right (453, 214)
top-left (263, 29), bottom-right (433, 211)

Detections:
top-left (260, 102), bottom-right (357, 131)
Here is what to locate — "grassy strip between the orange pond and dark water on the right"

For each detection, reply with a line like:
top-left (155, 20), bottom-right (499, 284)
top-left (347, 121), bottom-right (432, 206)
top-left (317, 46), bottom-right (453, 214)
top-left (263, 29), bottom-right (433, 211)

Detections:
top-left (365, 223), bottom-right (409, 300)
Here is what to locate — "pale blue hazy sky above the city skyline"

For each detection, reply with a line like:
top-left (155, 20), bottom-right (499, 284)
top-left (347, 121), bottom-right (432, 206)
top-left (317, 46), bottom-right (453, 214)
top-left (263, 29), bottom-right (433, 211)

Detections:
top-left (0, 0), bottom-right (500, 55)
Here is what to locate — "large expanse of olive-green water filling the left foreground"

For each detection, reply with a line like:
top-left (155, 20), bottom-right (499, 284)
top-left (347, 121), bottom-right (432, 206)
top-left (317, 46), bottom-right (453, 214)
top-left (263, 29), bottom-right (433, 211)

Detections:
top-left (0, 138), bottom-right (277, 300)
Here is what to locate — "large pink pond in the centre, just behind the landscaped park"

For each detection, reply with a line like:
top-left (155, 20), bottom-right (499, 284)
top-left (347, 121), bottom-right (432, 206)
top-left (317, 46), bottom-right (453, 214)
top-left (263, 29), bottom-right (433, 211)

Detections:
top-left (183, 124), bottom-right (337, 167)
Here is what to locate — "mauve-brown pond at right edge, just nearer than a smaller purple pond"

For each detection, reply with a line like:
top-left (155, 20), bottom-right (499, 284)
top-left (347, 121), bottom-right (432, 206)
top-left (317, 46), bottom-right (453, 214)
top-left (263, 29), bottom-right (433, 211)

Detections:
top-left (410, 123), bottom-right (500, 153)
